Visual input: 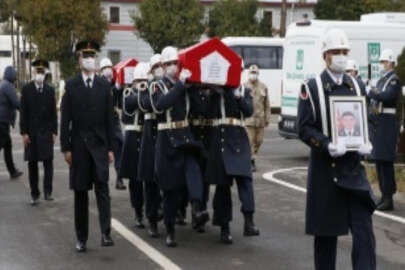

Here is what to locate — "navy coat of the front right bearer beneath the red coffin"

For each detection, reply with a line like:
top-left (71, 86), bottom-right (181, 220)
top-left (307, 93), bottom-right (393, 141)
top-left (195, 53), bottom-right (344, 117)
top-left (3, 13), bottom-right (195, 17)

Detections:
top-left (205, 89), bottom-right (253, 185)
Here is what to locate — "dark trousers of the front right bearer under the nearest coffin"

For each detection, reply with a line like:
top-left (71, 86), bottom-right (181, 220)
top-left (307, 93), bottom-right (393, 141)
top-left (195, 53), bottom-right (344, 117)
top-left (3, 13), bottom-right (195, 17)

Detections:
top-left (213, 176), bottom-right (255, 226)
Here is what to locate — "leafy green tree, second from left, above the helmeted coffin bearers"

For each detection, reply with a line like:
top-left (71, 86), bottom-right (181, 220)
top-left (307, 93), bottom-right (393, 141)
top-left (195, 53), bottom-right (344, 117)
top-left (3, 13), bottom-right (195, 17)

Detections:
top-left (131, 0), bottom-right (204, 52)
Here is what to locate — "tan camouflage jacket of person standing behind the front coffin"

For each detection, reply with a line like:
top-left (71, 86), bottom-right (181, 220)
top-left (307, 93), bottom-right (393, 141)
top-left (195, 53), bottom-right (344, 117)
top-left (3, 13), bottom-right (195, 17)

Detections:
top-left (245, 81), bottom-right (271, 127)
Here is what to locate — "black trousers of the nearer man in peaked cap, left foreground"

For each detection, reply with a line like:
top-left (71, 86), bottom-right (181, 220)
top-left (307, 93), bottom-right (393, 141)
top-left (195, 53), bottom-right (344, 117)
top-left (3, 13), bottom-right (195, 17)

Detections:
top-left (74, 182), bottom-right (111, 242)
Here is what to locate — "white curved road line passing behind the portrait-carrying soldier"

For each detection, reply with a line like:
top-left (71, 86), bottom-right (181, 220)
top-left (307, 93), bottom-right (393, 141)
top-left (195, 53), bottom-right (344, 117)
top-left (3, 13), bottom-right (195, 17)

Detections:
top-left (263, 167), bottom-right (405, 224)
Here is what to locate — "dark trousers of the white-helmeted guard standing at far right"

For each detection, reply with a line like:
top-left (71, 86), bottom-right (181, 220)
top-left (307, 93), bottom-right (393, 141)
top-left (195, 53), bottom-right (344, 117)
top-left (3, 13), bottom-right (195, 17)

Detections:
top-left (376, 160), bottom-right (397, 197)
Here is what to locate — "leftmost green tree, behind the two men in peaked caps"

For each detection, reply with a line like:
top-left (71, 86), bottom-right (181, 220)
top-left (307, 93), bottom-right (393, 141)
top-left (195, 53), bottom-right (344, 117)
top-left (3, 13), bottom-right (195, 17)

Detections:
top-left (19, 0), bottom-right (108, 78)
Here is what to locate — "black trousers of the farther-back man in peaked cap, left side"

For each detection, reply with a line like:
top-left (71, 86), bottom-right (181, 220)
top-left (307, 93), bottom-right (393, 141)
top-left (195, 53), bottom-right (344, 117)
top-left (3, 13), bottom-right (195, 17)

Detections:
top-left (28, 159), bottom-right (53, 199)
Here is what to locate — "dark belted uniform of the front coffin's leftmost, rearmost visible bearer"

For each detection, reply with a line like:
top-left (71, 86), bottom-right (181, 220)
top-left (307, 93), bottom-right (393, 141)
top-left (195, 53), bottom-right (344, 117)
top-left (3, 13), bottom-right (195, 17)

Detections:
top-left (120, 89), bottom-right (144, 228)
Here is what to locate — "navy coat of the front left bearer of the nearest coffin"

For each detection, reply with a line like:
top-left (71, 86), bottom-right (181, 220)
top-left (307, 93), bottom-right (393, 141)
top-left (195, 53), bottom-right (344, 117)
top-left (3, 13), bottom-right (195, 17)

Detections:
top-left (153, 78), bottom-right (202, 190)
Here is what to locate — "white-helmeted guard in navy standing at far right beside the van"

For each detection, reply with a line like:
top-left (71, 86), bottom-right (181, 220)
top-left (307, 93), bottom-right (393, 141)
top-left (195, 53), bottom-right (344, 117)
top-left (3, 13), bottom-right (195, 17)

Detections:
top-left (368, 49), bottom-right (401, 211)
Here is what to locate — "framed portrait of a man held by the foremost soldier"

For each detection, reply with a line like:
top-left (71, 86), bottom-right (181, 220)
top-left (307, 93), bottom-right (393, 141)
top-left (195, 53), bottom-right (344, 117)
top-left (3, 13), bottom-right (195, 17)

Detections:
top-left (329, 96), bottom-right (369, 151)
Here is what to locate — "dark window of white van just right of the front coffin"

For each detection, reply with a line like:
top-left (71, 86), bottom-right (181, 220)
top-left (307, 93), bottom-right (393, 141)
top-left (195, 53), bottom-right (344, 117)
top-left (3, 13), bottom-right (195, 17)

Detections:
top-left (231, 46), bottom-right (283, 69)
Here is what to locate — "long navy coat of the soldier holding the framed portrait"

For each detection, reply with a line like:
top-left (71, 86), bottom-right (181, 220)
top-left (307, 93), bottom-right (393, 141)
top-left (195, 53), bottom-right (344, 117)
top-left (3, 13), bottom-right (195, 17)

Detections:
top-left (297, 71), bottom-right (375, 236)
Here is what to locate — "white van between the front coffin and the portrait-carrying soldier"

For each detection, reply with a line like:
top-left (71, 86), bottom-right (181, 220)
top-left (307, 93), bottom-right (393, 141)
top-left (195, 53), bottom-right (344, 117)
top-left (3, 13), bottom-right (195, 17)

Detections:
top-left (222, 37), bottom-right (284, 111)
